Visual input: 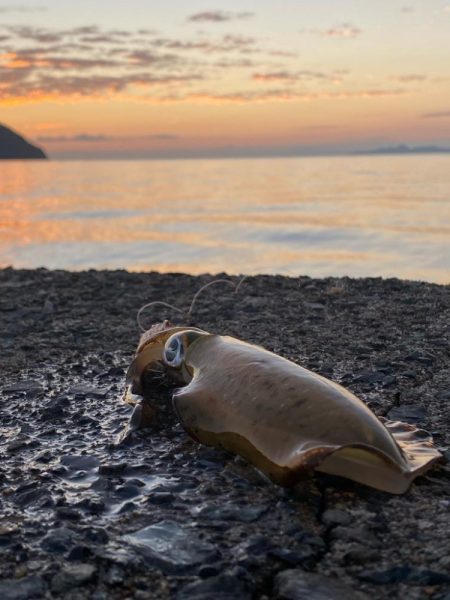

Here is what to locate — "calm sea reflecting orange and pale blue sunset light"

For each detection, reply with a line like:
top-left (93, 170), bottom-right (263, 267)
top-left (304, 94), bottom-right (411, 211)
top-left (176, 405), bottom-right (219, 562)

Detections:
top-left (0, 155), bottom-right (450, 283)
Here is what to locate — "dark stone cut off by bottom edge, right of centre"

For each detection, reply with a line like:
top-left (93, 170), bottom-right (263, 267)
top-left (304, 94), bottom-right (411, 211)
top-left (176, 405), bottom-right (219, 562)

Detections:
top-left (274, 569), bottom-right (364, 600)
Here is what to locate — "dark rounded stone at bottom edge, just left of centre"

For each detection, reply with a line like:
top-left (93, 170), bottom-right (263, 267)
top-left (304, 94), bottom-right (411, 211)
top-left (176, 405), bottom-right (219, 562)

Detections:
top-left (176, 573), bottom-right (251, 600)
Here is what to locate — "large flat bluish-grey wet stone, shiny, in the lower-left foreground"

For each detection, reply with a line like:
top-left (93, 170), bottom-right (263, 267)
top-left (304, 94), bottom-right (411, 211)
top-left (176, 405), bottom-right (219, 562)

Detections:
top-left (123, 521), bottom-right (217, 573)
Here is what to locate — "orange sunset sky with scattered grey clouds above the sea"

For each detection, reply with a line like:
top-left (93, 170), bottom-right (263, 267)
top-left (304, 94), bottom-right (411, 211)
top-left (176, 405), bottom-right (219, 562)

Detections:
top-left (0, 0), bottom-right (450, 158)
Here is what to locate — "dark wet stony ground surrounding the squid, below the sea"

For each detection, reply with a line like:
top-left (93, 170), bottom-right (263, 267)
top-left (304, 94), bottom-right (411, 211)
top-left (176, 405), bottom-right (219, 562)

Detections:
top-left (0, 268), bottom-right (450, 600)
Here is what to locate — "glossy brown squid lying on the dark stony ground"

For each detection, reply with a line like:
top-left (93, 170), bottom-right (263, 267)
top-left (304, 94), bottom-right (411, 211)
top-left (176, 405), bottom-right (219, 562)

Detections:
top-left (124, 321), bottom-right (442, 494)
